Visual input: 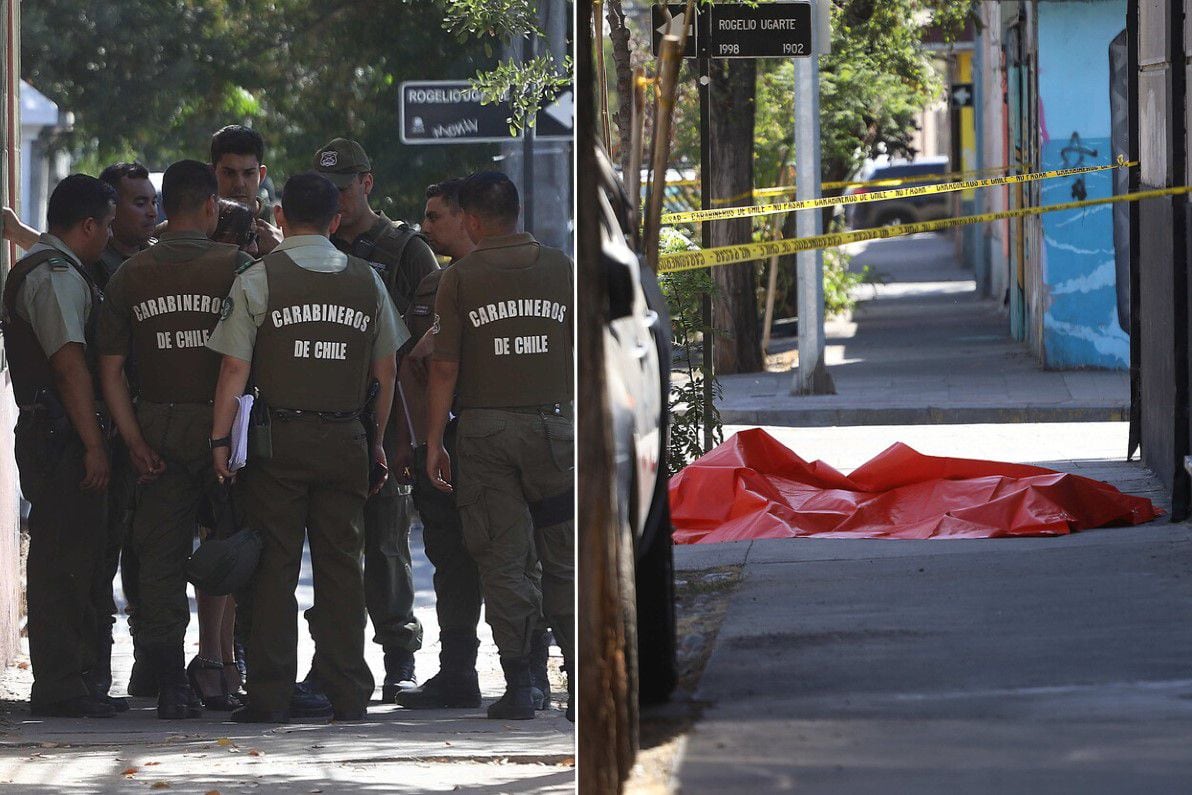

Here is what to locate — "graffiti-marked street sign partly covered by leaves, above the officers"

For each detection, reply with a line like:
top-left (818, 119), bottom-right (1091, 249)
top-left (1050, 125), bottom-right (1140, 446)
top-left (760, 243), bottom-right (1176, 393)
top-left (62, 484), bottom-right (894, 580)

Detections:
top-left (398, 80), bottom-right (572, 144)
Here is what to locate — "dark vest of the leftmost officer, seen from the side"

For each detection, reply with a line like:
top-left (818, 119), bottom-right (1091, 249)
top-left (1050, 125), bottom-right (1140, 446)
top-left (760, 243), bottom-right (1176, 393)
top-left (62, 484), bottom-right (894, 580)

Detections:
top-left (4, 250), bottom-right (104, 405)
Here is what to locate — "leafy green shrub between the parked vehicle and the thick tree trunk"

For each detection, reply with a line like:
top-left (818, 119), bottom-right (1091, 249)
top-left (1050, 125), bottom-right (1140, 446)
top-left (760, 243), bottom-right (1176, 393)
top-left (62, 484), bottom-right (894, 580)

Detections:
top-left (658, 228), bottom-right (725, 474)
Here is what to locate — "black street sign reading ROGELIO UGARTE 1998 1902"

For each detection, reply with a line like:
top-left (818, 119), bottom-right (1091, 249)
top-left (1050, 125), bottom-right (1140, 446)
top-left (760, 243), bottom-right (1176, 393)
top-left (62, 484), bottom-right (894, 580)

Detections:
top-left (708, 2), bottom-right (812, 58)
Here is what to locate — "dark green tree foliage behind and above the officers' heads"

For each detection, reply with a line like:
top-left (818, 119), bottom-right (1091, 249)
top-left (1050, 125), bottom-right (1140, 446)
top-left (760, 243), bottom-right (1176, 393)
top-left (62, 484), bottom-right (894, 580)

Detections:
top-left (21, 0), bottom-right (553, 221)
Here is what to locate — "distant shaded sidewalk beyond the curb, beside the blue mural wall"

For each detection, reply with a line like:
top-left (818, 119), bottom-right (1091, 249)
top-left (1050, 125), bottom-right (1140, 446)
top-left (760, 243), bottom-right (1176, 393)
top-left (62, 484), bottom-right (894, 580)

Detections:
top-left (719, 234), bottom-right (1130, 426)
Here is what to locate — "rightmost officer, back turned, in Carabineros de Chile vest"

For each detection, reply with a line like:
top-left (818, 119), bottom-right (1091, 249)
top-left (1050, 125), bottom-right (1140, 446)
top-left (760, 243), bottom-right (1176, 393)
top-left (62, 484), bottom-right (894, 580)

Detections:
top-left (427, 172), bottom-right (576, 720)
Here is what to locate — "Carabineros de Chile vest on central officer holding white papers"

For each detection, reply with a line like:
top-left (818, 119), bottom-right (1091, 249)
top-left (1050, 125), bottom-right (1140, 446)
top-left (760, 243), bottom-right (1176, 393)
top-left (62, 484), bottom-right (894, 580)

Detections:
top-left (253, 251), bottom-right (381, 412)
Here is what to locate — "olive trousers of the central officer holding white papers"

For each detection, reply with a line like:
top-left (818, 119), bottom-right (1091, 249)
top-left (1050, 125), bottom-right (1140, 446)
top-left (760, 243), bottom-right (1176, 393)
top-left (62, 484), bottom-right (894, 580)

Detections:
top-left (238, 415), bottom-right (373, 712)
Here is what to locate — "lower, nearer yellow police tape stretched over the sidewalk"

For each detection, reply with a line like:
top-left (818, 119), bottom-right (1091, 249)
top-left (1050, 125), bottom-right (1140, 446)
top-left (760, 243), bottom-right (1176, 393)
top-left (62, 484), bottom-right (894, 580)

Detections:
top-left (658, 186), bottom-right (1192, 273)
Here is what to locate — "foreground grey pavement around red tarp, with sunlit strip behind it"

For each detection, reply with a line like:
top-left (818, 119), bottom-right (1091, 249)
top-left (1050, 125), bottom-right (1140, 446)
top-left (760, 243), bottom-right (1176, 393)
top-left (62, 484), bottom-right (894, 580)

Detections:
top-left (673, 423), bottom-right (1192, 794)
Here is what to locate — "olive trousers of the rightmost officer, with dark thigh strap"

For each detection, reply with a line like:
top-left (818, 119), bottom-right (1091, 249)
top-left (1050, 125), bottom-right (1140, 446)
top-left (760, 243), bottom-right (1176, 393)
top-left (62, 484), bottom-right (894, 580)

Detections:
top-left (453, 409), bottom-right (575, 662)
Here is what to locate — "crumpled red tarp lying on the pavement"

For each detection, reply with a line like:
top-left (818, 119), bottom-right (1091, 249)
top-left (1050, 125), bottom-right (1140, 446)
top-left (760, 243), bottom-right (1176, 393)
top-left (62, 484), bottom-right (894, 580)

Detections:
top-left (670, 429), bottom-right (1162, 544)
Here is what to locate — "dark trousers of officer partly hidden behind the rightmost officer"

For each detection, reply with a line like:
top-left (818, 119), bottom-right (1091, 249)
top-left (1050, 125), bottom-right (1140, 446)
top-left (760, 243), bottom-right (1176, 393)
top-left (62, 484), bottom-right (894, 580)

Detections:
top-left (414, 421), bottom-right (482, 634)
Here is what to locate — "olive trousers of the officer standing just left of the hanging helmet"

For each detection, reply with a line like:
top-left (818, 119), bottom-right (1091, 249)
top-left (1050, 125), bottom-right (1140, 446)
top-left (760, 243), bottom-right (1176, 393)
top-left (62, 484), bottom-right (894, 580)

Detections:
top-left (132, 400), bottom-right (219, 648)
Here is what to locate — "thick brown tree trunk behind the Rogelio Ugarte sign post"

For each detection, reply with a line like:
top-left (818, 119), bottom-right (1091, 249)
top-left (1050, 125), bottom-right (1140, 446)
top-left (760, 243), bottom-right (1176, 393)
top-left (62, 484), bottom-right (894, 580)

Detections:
top-left (709, 58), bottom-right (764, 374)
